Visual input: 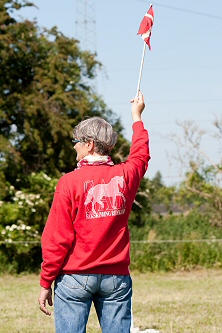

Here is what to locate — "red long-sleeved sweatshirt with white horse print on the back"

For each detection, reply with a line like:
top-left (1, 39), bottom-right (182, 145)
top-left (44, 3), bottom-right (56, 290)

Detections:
top-left (40, 121), bottom-right (150, 288)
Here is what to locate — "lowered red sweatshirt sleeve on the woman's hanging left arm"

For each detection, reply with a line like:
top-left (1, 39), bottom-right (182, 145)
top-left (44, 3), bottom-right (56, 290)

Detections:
top-left (40, 178), bottom-right (75, 288)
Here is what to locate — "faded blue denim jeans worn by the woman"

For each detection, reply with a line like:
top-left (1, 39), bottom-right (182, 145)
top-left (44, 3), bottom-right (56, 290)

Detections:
top-left (54, 274), bottom-right (132, 333)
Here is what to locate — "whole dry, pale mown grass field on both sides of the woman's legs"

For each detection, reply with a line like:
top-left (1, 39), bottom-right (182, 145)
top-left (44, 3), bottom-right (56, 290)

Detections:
top-left (0, 270), bottom-right (222, 333)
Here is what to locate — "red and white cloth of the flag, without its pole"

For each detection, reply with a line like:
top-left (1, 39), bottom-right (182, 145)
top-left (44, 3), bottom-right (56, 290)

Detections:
top-left (137, 5), bottom-right (154, 50)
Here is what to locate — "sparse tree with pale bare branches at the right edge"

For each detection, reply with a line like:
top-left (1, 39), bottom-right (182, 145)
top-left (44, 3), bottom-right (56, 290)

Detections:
top-left (171, 117), bottom-right (222, 227)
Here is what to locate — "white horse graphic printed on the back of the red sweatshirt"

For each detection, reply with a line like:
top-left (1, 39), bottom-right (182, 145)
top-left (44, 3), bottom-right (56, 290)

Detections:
top-left (84, 176), bottom-right (126, 213)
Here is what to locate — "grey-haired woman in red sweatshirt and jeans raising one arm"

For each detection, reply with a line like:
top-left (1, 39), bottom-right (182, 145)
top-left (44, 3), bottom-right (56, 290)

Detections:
top-left (39, 92), bottom-right (150, 333)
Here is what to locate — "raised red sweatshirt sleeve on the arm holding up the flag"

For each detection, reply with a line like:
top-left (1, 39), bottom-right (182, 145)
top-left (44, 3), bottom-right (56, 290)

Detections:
top-left (127, 121), bottom-right (151, 181)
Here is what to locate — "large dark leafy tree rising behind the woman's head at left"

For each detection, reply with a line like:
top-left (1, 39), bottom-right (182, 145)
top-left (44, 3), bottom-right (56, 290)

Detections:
top-left (0, 0), bottom-right (129, 186)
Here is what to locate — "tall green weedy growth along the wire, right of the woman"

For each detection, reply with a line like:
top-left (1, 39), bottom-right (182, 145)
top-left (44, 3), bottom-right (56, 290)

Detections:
top-left (131, 211), bottom-right (222, 272)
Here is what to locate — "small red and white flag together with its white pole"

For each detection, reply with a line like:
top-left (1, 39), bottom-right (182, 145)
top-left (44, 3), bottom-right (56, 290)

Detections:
top-left (136, 4), bottom-right (154, 96)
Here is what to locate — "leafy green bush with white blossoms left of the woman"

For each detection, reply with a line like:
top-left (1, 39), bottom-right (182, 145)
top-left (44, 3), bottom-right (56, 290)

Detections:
top-left (0, 172), bottom-right (57, 273)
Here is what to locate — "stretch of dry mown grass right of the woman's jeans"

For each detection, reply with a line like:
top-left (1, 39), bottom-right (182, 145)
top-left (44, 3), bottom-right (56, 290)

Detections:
top-left (133, 270), bottom-right (222, 333)
